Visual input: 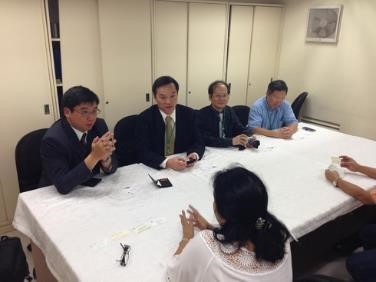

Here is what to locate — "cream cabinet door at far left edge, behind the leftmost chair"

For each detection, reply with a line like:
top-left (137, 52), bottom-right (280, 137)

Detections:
top-left (0, 0), bottom-right (54, 227)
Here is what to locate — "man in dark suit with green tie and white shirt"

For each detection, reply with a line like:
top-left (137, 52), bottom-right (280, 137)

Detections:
top-left (137, 76), bottom-right (205, 170)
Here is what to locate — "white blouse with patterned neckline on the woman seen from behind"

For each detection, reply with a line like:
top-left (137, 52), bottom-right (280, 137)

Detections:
top-left (166, 230), bottom-right (292, 282)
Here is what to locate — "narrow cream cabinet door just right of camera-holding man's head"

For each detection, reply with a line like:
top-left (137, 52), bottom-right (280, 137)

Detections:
top-left (227, 5), bottom-right (254, 106)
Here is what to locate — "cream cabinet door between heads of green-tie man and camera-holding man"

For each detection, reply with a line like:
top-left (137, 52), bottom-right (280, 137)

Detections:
top-left (187, 3), bottom-right (227, 109)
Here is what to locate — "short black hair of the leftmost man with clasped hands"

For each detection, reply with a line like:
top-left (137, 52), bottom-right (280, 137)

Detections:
top-left (61, 86), bottom-right (99, 111)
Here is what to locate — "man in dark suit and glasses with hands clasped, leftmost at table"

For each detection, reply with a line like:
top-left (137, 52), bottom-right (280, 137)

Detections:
top-left (40, 86), bottom-right (117, 194)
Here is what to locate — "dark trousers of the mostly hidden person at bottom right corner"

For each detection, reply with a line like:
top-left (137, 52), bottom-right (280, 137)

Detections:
top-left (346, 224), bottom-right (376, 282)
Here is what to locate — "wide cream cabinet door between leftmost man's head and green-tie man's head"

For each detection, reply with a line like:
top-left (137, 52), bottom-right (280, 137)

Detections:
top-left (98, 0), bottom-right (151, 128)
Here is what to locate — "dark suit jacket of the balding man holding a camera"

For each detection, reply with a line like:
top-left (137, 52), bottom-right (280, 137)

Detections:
top-left (198, 105), bottom-right (248, 147)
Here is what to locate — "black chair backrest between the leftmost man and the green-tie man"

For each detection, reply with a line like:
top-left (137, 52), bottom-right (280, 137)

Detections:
top-left (114, 115), bottom-right (138, 166)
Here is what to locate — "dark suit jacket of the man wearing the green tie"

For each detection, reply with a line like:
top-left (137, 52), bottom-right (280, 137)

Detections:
top-left (136, 105), bottom-right (205, 169)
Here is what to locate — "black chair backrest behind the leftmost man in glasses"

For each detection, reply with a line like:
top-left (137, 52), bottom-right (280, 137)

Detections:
top-left (15, 128), bottom-right (47, 192)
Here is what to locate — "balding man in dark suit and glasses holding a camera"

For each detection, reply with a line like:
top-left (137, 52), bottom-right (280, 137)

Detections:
top-left (198, 80), bottom-right (248, 147)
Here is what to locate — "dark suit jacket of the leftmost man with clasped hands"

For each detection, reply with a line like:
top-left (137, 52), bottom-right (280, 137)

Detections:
top-left (40, 118), bottom-right (117, 194)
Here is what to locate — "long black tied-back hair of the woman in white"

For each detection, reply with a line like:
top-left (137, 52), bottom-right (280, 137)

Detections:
top-left (213, 167), bottom-right (290, 262)
